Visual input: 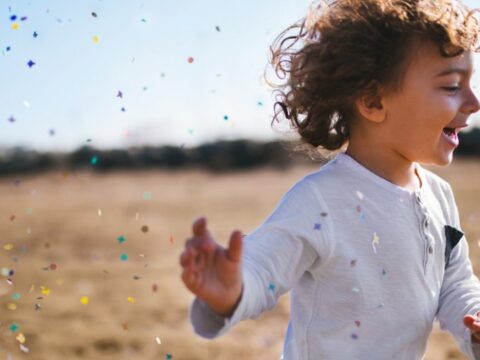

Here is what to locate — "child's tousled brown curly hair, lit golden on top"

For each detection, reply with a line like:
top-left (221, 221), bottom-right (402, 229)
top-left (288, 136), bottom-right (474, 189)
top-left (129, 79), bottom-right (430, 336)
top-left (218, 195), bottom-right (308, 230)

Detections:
top-left (267, 0), bottom-right (480, 155)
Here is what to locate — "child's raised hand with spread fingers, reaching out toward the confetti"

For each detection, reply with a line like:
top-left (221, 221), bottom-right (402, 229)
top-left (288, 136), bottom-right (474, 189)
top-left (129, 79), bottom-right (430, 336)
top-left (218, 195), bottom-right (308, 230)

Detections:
top-left (180, 218), bottom-right (242, 317)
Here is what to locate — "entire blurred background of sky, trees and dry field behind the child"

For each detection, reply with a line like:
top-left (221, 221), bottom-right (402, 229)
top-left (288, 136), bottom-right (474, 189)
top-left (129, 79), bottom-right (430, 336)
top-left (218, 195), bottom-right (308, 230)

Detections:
top-left (0, 0), bottom-right (480, 360)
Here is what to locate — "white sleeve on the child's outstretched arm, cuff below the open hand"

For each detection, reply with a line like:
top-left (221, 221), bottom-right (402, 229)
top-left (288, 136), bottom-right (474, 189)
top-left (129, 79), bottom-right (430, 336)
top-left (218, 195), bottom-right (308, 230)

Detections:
top-left (190, 179), bottom-right (330, 338)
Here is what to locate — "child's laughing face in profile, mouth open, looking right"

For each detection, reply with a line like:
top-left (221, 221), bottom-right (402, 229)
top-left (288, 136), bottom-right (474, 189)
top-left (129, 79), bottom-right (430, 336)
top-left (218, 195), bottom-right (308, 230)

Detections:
top-left (382, 40), bottom-right (480, 165)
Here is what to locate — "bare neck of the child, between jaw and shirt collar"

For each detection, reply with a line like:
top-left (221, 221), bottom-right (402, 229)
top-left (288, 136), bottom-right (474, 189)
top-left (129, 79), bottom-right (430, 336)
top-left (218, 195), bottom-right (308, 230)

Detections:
top-left (345, 143), bottom-right (422, 191)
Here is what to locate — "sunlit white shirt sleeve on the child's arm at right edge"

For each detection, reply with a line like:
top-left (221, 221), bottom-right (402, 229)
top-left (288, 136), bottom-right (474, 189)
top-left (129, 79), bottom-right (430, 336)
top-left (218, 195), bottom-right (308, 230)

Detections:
top-left (437, 185), bottom-right (480, 360)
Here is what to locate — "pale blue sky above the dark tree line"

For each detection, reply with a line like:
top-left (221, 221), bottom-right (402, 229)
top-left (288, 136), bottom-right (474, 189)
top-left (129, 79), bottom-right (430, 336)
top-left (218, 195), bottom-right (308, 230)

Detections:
top-left (0, 0), bottom-right (480, 151)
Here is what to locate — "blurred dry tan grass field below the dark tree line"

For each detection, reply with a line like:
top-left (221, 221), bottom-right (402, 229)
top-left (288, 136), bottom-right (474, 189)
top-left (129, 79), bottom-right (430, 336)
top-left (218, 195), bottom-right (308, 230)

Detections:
top-left (0, 160), bottom-right (480, 360)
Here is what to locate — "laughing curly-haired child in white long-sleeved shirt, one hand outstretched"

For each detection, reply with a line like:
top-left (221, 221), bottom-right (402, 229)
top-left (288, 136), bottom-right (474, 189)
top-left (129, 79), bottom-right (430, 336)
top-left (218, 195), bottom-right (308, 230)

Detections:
top-left (180, 0), bottom-right (480, 360)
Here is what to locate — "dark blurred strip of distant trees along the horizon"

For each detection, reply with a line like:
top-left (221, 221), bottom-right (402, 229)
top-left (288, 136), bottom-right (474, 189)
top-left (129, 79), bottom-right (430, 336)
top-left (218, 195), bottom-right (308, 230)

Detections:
top-left (0, 128), bottom-right (480, 176)
